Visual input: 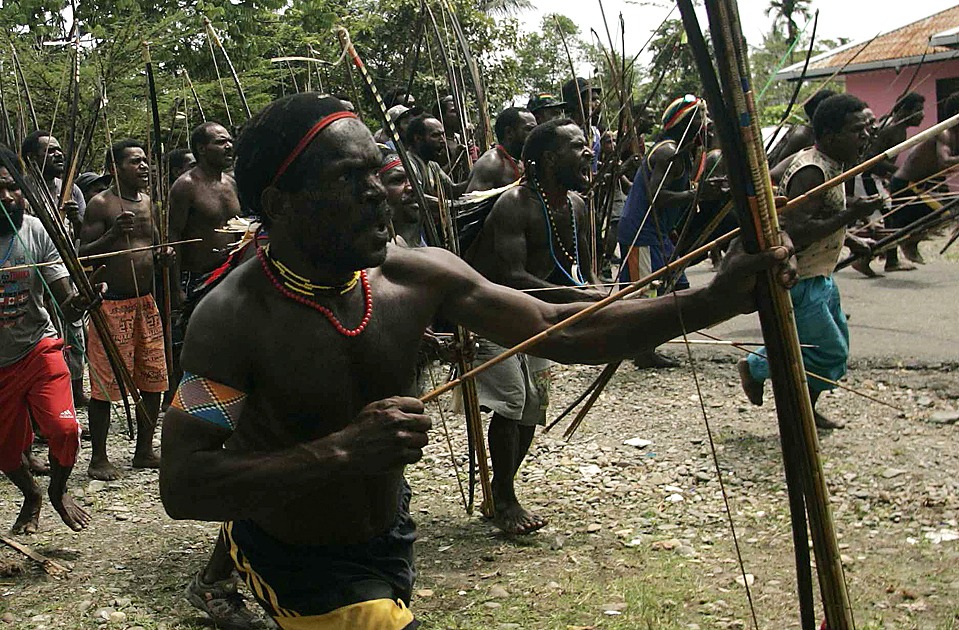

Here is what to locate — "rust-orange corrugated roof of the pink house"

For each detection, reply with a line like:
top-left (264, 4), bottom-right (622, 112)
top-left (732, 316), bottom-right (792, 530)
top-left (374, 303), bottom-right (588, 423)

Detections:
top-left (777, 5), bottom-right (959, 79)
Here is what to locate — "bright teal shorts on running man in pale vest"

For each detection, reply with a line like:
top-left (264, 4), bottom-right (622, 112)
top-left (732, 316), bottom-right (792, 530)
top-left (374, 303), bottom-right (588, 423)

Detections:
top-left (747, 276), bottom-right (849, 392)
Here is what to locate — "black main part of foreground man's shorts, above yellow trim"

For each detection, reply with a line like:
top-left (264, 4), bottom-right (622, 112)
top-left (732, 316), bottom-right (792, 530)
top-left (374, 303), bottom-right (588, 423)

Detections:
top-left (228, 481), bottom-right (416, 616)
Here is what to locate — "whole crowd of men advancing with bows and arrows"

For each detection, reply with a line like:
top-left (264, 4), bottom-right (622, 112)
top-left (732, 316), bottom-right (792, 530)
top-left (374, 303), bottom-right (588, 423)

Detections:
top-left (0, 71), bottom-right (959, 630)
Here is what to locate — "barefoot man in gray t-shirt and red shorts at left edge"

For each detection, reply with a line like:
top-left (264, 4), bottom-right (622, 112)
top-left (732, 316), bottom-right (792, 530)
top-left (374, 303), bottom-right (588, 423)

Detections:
top-left (0, 145), bottom-right (90, 534)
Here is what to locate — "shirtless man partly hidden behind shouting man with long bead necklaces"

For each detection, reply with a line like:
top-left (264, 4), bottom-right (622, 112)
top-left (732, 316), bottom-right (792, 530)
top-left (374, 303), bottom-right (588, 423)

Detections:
top-left (466, 107), bottom-right (536, 192)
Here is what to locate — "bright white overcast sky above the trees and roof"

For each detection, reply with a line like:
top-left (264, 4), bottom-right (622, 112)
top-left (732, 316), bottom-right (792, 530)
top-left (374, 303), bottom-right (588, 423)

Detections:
top-left (519, 0), bottom-right (959, 64)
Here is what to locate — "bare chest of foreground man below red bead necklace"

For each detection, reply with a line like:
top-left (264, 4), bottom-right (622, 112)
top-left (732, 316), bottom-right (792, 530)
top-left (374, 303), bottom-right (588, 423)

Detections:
top-left (240, 284), bottom-right (430, 447)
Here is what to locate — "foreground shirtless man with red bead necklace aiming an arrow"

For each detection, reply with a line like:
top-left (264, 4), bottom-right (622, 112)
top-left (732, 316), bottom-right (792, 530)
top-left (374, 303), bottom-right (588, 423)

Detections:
top-left (160, 94), bottom-right (791, 630)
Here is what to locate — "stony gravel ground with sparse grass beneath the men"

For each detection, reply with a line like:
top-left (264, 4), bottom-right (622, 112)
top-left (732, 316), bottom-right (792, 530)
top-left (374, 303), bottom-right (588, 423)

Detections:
top-left (0, 354), bottom-right (959, 630)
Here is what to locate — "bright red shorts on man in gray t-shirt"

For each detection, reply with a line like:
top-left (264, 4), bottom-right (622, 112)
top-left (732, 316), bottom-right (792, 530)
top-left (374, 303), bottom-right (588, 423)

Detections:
top-left (0, 337), bottom-right (80, 472)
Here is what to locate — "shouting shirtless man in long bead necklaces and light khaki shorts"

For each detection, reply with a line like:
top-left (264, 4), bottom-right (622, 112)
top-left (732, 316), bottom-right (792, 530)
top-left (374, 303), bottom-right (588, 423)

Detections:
top-left (470, 118), bottom-right (604, 534)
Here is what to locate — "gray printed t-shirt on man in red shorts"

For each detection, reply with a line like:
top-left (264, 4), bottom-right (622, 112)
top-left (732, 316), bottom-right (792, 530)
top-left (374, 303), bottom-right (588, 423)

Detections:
top-left (0, 215), bottom-right (69, 367)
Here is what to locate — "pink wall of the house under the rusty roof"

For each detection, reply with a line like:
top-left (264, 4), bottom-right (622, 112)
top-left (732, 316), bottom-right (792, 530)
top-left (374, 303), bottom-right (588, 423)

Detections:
top-left (845, 59), bottom-right (959, 136)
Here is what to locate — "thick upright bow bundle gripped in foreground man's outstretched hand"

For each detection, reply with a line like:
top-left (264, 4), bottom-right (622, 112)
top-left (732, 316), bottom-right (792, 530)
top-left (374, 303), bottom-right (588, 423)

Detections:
top-left (706, 0), bottom-right (856, 630)
